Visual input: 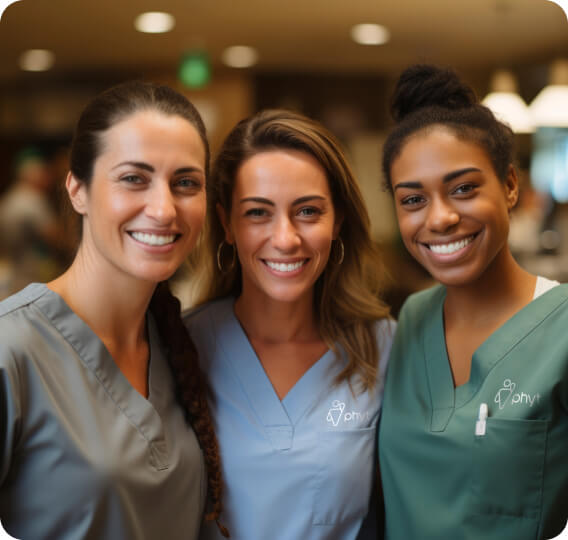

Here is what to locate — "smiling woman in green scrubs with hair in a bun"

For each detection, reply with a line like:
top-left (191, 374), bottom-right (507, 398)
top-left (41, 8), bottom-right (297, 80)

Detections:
top-left (379, 65), bottom-right (568, 540)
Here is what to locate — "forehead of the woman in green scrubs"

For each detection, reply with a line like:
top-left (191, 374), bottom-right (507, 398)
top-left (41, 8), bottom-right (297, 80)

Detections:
top-left (391, 126), bottom-right (493, 185)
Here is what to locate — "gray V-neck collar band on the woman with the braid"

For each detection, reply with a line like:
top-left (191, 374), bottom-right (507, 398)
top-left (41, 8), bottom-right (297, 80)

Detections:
top-left (27, 283), bottom-right (171, 470)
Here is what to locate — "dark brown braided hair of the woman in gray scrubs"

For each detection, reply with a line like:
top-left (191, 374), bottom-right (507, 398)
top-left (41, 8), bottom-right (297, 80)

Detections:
top-left (70, 81), bottom-right (228, 536)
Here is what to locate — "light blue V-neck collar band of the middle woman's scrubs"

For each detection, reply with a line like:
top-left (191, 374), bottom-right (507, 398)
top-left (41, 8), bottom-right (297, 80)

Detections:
top-left (215, 297), bottom-right (336, 450)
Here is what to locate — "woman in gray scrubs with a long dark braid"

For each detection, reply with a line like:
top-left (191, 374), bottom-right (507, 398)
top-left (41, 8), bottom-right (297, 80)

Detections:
top-left (0, 82), bottom-right (226, 540)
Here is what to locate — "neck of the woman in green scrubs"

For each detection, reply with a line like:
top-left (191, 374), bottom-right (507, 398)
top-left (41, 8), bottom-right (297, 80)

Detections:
top-left (444, 248), bottom-right (536, 324)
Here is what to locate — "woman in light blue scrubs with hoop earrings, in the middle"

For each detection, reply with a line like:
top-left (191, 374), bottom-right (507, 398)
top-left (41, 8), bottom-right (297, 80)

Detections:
top-left (185, 111), bottom-right (394, 540)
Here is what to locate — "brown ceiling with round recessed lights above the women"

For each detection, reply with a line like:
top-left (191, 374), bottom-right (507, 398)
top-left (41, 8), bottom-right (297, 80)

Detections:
top-left (0, 0), bottom-right (568, 84)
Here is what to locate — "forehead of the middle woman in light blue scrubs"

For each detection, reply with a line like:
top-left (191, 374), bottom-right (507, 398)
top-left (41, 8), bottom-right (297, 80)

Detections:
top-left (234, 150), bottom-right (330, 198)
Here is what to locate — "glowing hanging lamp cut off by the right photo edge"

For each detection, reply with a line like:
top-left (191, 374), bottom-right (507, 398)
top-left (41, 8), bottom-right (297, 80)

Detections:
top-left (529, 60), bottom-right (568, 127)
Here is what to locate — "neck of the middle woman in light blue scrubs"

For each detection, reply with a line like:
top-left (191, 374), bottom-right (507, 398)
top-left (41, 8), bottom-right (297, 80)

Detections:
top-left (235, 290), bottom-right (321, 343)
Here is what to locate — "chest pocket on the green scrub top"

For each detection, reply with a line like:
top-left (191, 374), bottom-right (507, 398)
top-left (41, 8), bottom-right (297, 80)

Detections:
top-left (470, 418), bottom-right (548, 524)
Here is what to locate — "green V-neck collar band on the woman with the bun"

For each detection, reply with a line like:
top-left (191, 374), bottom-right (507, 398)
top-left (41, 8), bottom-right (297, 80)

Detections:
top-left (424, 285), bottom-right (568, 431)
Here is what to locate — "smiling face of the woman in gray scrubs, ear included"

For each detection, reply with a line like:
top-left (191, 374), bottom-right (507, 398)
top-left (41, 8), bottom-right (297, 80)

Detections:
top-left (67, 110), bottom-right (206, 282)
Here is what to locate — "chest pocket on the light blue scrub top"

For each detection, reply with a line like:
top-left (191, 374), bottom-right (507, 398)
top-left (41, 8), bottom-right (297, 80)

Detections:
top-left (313, 427), bottom-right (377, 525)
